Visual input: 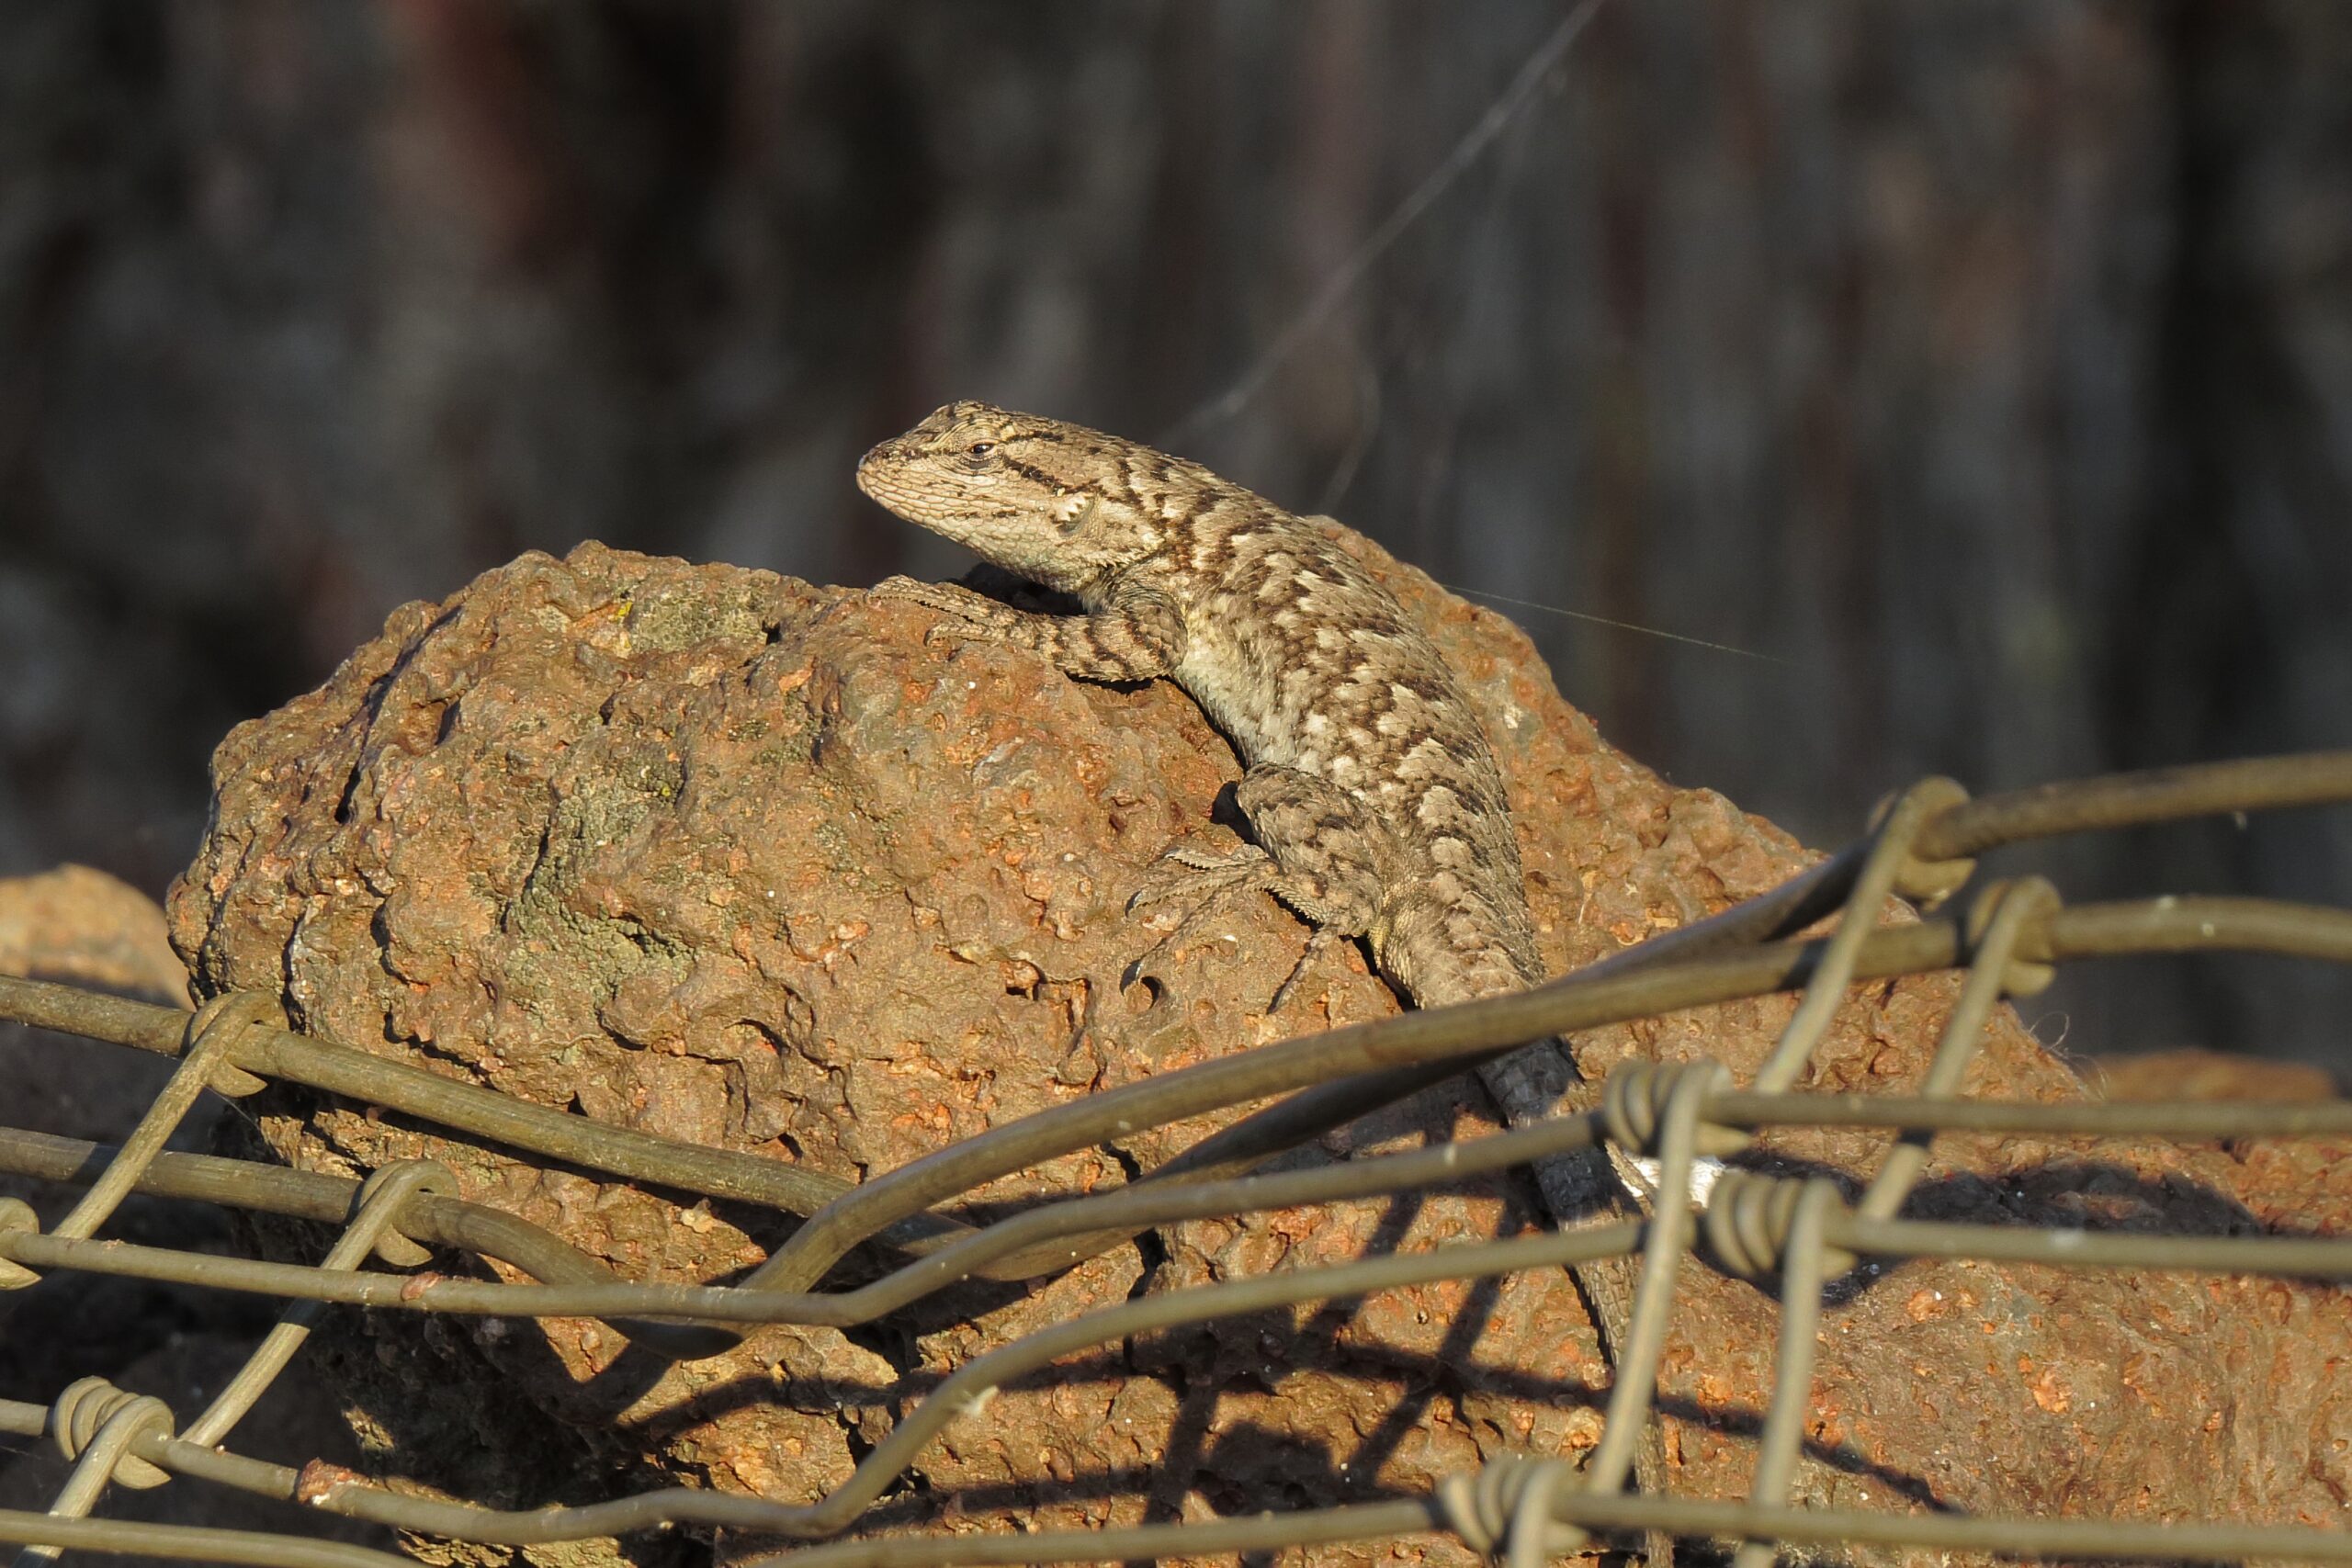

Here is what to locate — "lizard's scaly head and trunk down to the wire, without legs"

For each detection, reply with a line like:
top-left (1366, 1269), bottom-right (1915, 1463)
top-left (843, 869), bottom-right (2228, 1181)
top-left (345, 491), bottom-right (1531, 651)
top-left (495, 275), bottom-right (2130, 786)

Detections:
top-left (858, 402), bottom-right (1543, 1006)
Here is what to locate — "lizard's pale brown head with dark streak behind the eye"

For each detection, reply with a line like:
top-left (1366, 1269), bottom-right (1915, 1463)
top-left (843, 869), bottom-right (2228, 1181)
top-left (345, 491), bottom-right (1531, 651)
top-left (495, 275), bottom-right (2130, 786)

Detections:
top-left (858, 402), bottom-right (1173, 592)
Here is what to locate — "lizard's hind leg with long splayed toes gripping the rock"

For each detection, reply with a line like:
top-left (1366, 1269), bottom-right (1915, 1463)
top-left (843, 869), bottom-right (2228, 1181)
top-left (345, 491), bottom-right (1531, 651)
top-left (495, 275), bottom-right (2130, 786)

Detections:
top-left (1126, 761), bottom-right (1385, 1013)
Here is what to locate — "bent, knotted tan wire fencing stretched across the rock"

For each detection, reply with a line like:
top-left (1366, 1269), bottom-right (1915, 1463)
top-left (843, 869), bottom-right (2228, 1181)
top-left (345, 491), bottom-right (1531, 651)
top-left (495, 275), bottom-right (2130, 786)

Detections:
top-left (0, 752), bottom-right (2352, 1568)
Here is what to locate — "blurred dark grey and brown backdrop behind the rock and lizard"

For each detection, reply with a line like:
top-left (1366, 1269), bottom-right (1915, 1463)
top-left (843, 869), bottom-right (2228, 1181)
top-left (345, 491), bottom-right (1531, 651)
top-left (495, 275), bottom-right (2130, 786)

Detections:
top-left (0, 0), bottom-right (2352, 1063)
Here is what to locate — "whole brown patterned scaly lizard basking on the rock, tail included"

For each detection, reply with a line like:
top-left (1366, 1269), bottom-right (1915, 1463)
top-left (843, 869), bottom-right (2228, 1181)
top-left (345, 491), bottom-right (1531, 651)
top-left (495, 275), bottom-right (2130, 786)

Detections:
top-left (856, 402), bottom-right (1693, 1541)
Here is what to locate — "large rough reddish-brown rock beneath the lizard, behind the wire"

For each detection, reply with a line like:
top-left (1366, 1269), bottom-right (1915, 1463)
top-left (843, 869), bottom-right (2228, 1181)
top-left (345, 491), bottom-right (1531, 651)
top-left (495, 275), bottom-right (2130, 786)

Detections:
top-left (172, 546), bottom-right (2352, 1561)
